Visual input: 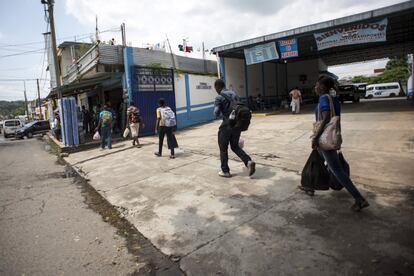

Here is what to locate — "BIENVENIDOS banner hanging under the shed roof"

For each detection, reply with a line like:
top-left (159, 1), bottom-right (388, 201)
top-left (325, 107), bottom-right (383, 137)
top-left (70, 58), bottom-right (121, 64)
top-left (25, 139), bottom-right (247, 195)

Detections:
top-left (313, 18), bottom-right (388, 51)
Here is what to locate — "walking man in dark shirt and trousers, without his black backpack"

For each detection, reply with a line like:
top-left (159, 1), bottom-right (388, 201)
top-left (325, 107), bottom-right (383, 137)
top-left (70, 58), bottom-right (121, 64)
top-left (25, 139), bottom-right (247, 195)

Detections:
top-left (214, 79), bottom-right (256, 177)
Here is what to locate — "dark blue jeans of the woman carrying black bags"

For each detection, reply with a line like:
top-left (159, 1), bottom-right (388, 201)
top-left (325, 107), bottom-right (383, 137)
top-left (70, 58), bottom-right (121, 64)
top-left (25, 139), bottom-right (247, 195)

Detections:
top-left (318, 150), bottom-right (364, 200)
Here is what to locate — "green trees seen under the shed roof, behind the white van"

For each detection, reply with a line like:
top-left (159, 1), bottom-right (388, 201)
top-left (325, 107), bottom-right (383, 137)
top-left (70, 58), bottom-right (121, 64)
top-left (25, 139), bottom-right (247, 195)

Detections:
top-left (352, 57), bottom-right (409, 84)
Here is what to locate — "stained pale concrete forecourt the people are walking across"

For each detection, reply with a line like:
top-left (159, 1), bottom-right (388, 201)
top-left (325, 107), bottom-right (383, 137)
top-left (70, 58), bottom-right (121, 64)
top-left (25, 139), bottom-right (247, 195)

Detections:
top-left (65, 99), bottom-right (414, 275)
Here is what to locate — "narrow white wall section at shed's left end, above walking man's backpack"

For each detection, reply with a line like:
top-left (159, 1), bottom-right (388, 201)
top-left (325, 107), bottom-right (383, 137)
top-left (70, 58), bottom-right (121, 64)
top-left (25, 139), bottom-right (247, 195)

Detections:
top-left (224, 58), bottom-right (246, 97)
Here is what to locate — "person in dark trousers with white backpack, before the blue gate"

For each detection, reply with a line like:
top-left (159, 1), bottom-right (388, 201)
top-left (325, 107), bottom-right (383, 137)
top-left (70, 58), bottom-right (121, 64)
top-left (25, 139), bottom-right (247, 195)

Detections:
top-left (154, 98), bottom-right (178, 159)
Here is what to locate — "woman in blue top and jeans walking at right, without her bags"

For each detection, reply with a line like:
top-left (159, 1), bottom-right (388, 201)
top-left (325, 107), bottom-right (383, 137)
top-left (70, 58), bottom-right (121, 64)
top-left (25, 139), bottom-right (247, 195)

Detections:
top-left (312, 76), bottom-right (369, 212)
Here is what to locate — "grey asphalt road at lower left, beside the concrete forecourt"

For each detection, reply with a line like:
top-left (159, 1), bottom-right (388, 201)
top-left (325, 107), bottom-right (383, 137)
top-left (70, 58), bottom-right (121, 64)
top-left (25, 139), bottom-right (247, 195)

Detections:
top-left (0, 136), bottom-right (180, 275)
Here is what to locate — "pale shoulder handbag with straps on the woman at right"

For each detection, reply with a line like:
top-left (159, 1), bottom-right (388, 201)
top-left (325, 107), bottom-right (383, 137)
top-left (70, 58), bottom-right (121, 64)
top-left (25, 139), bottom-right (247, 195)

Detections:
top-left (314, 95), bottom-right (342, 150)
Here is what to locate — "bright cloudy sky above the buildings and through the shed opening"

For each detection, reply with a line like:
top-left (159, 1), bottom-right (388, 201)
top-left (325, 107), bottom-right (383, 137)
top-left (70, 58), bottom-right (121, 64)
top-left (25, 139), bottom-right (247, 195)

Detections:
top-left (0, 0), bottom-right (403, 100)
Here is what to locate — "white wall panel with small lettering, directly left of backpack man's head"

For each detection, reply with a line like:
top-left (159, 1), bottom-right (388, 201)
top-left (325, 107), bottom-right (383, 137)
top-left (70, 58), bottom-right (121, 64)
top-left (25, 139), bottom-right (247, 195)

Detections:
top-left (189, 75), bottom-right (217, 105)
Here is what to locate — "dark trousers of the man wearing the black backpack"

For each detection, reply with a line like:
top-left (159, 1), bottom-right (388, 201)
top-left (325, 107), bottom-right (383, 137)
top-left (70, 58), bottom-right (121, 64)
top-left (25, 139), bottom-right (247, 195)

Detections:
top-left (218, 125), bottom-right (252, 172)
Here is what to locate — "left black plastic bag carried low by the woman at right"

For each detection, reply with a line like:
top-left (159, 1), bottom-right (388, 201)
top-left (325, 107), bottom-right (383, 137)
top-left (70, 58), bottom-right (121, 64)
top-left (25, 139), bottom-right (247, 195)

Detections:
top-left (301, 150), bottom-right (330, 190)
